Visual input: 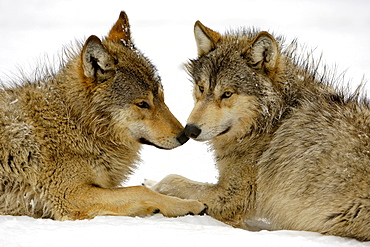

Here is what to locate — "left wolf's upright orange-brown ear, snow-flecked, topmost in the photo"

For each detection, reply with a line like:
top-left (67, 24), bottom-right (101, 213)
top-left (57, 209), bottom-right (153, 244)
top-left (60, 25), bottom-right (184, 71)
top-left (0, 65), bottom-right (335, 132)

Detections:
top-left (107, 11), bottom-right (131, 45)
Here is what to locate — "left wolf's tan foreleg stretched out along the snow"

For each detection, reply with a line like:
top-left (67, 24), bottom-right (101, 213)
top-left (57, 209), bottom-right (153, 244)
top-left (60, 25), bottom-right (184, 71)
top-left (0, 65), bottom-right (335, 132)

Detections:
top-left (55, 186), bottom-right (206, 220)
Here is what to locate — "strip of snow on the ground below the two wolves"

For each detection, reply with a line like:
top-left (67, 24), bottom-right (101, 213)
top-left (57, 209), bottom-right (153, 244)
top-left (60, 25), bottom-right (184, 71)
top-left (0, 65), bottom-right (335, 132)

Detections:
top-left (0, 215), bottom-right (365, 247)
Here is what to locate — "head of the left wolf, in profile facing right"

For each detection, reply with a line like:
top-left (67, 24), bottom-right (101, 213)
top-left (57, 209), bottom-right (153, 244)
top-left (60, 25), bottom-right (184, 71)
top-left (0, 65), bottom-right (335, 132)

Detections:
top-left (75, 12), bottom-right (188, 149)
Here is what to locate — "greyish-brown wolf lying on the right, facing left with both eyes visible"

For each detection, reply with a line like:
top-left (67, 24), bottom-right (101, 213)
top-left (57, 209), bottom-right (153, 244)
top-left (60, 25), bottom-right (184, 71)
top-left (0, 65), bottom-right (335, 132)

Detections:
top-left (152, 21), bottom-right (370, 241)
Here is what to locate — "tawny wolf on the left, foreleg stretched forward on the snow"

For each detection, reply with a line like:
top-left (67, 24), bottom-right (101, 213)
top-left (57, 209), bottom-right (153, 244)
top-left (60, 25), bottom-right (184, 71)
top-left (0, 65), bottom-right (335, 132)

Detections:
top-left (0, 11), bottom-right (206, 220)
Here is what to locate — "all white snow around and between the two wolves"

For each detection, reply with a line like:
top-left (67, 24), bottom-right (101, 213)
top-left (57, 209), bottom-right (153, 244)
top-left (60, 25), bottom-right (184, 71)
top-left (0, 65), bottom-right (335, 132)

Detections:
top-left (0, 0), bottom-right (370, 247)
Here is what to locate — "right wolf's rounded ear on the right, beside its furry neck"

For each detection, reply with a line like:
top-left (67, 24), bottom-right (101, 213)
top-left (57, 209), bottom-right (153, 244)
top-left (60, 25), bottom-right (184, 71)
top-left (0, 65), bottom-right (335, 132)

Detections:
top-left (244, 32), bottom-right (278, 72)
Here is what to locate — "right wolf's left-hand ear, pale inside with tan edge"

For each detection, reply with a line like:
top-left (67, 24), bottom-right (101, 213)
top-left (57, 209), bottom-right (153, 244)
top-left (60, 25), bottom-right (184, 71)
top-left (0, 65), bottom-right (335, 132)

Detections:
top-left (194, 21), bottom-right (221, 56)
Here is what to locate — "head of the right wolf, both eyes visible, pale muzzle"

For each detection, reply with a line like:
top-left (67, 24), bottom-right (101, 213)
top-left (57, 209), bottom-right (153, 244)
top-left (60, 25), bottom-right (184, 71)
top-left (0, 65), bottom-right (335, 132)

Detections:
top-left (185, 21), bottom-right (279, 141)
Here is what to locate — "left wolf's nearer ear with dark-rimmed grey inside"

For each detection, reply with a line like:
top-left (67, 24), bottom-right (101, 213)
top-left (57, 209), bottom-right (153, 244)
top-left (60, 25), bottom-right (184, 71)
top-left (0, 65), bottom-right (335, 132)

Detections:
top-left (81, 35), bottom-right (114, 82)
